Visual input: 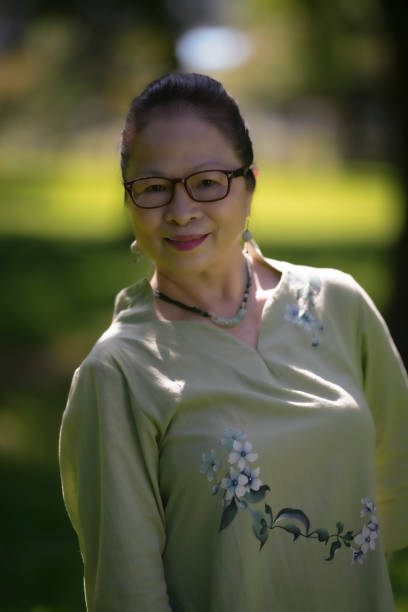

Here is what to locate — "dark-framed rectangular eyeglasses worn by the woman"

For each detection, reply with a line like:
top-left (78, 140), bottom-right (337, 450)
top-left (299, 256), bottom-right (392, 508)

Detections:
top-left (123, 166), bottom-right (249, 208)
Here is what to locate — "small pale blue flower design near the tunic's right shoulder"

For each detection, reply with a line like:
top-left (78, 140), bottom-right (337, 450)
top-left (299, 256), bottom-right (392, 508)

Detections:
top-left (285, 276), bottom-right (323, 346)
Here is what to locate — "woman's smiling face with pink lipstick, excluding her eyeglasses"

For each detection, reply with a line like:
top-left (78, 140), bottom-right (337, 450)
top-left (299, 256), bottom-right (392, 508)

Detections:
top-left (126, 112), bottom-right (252, 278)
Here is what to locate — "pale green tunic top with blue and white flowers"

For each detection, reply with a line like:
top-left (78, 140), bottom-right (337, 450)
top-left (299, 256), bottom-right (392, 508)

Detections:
top-left (60, 253), bottom-right (408, 612)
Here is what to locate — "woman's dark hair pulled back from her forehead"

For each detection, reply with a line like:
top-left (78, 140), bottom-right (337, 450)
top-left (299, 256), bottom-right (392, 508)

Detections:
top-left (120, 73), bottom-right (255, 190)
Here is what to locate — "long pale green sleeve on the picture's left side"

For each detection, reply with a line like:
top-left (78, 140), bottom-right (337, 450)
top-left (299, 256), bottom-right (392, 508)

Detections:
top-left (60, 357), bottom-right (170, 612)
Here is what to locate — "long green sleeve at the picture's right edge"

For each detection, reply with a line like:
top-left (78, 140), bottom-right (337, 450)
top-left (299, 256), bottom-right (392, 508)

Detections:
top-left (359, 288), bottom-right (408, 552)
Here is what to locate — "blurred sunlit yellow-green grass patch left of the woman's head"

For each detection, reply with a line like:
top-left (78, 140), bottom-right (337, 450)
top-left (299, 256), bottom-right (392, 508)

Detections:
top-left (0, 155), bottom-right (126, 239)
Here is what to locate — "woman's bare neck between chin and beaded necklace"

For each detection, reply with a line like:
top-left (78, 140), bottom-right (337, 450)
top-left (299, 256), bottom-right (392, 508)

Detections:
top-left (151, 249), bottom-right (247, 317)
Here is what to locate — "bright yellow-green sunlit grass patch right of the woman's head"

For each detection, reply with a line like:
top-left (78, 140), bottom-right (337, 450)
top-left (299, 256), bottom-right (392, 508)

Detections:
top-left (250, 167), bottom-right (403, 244)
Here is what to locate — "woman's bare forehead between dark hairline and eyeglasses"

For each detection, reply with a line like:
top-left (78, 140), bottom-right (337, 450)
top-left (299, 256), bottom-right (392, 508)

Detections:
top-left (129, 112), bottom-right (240, 176)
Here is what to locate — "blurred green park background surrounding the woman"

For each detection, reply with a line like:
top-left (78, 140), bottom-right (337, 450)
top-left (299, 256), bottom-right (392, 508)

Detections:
top-left (0, 0), bottom-right (408, 612)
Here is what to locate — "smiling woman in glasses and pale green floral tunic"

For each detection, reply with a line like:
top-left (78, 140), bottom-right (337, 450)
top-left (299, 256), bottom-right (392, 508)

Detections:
top-left (60, 74), bottom-right (408, 612)
